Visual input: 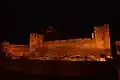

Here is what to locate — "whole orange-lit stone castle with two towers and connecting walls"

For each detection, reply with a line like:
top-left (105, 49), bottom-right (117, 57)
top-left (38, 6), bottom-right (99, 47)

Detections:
top-left (2, 24), bottom-right (111, 57)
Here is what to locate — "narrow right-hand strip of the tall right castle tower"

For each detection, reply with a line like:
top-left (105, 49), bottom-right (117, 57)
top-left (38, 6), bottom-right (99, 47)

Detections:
top-left (104, 24), bottom-right (110, 49)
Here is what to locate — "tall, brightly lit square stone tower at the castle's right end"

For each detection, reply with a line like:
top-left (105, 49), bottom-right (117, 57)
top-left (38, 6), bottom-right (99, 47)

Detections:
top-left (94, 24), bottom-right (110, 49)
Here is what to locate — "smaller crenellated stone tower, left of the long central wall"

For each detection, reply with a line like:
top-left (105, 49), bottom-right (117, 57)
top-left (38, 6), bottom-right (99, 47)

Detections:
top-left (29, 33), bottom-right (44, 53)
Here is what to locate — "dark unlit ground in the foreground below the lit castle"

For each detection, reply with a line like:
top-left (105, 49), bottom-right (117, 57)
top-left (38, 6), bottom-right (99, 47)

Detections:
top-left (0, 60), bottom-right (117, 80)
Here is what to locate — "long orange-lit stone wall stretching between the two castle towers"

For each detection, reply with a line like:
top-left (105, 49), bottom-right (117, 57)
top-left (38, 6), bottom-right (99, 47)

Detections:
top-left (40, 40), bottom-right (109, 56)
